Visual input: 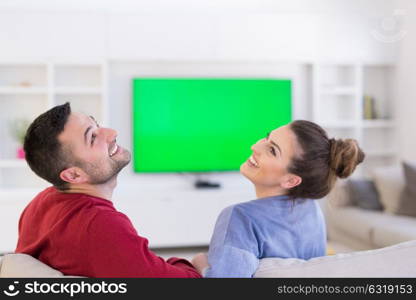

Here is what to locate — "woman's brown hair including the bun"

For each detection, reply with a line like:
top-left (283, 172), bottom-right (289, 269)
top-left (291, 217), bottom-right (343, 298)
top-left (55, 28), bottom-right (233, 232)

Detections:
top-left (288, 120), bottom-right (365, 199)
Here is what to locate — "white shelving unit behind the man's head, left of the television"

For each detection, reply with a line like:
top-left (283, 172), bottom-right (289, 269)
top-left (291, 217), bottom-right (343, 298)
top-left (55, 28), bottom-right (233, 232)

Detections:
top-left (0, 60), bottom-right (108, 195)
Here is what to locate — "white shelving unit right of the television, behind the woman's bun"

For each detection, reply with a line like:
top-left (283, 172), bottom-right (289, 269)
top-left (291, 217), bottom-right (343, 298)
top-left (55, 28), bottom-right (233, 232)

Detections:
top-left (312, 63), bottom-right (397, 177)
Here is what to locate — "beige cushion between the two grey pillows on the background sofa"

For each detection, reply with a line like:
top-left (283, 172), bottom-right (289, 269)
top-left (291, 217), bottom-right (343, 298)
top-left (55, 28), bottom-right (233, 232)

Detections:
top-left (372, 165), bottom-right (405, 214)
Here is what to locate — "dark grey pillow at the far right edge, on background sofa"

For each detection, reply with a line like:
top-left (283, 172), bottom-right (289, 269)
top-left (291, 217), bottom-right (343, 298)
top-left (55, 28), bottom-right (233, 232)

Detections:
top-left (397, 162), bottom-right (416, 216)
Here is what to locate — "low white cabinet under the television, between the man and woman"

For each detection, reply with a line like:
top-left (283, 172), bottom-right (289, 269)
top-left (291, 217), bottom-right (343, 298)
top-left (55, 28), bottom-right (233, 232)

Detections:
top-left (113, 177), bottom-right (256, 248)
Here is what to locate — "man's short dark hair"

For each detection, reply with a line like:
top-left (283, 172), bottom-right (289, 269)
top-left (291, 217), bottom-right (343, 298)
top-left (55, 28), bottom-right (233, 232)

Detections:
top-left (23, 102), bottom-right (71, 190)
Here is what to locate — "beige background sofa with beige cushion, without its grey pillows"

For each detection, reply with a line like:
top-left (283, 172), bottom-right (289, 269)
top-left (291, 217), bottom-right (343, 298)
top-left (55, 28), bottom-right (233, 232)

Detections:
top-left (323, 165), bottom-right (416, 250)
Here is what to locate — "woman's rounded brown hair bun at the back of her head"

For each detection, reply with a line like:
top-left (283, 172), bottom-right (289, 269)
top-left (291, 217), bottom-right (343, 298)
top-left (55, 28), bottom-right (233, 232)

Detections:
top-left (329, 138), bottom-right (365, 178)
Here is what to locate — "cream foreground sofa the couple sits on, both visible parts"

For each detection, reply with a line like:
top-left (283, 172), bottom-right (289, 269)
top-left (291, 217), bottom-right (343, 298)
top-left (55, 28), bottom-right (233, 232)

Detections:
top-left (0, 240), bottom-right (416, 278)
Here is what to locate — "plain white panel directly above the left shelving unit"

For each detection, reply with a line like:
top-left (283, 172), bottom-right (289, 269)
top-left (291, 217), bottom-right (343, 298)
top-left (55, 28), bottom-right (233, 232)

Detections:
top-left (0, 9), bottom-right (107, 60)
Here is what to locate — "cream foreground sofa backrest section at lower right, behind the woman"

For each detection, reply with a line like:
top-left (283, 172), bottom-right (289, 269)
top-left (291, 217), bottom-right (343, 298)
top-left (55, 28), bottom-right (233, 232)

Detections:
top-left (255, 241), bottom-right (416, 278)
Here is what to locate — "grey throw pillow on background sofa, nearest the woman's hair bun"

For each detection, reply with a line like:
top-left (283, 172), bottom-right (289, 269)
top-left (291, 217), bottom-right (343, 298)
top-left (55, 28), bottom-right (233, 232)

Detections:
top-left (348, 179), bottom-right (383, 210)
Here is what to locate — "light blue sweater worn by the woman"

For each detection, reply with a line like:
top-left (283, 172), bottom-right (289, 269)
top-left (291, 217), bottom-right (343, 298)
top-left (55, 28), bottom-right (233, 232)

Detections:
top-left (204, 196), bottom-right (326, 277)
